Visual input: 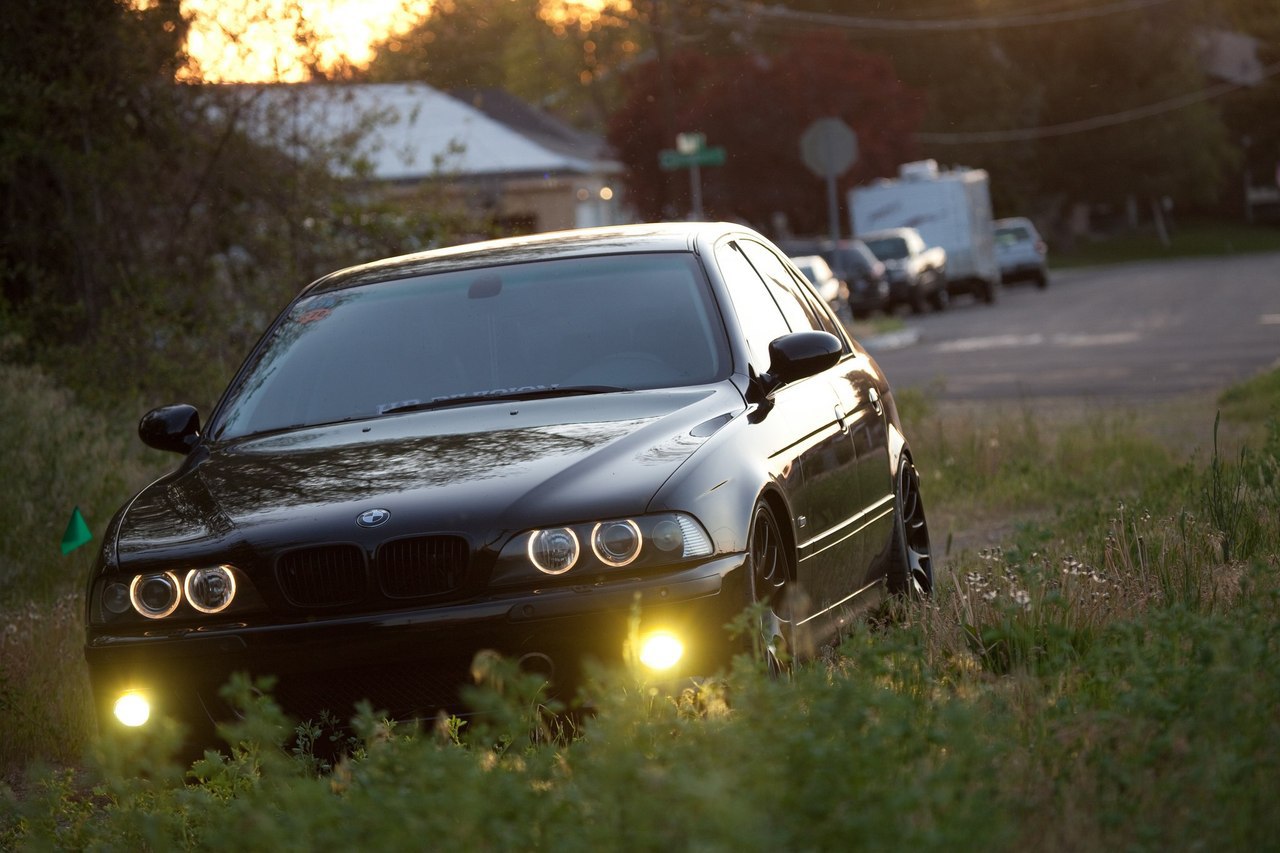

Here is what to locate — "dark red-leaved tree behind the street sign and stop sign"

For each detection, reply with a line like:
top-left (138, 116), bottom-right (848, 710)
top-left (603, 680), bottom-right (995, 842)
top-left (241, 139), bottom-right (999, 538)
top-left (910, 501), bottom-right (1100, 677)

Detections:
top-left (608, 35), bottom-right (923, 233)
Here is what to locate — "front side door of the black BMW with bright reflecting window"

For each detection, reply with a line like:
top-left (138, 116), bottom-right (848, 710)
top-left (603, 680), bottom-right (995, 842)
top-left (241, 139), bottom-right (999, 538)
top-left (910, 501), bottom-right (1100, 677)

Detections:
top-left (722, 240), bottom-right (864, 622)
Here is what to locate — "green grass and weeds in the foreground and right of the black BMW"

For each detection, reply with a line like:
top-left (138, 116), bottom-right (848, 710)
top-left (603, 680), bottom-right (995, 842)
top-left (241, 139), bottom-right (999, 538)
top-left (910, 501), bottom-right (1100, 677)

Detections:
top-left (0, 361), bottom-right (1280, 850)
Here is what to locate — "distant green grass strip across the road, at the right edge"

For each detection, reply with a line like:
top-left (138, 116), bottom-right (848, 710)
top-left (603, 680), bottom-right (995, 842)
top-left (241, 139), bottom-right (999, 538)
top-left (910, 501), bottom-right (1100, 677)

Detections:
top-left (1050, 216), bottom-right (1280, 269)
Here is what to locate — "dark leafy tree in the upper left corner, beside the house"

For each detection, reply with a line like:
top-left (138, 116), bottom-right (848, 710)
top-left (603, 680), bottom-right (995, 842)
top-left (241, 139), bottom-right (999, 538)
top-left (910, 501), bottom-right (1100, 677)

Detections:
top-left (0, 0), bottom-right (471, 412)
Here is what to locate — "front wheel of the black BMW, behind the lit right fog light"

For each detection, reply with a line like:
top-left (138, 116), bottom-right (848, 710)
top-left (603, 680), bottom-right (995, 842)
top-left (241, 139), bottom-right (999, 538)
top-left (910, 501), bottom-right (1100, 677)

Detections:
top-left (746, 501), bottom-right (791, 675)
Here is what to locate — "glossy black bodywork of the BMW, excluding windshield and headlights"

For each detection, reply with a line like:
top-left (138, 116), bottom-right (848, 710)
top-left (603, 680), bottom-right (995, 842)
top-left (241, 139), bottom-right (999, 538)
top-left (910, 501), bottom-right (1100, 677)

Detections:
top-left (86, 223), bottom-right (928, 742)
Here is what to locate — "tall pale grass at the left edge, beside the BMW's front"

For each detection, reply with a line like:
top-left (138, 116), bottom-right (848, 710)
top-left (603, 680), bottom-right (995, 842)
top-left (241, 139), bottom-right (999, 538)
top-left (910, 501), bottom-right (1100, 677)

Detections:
top-left (0, 364), bottom-right (170, 768)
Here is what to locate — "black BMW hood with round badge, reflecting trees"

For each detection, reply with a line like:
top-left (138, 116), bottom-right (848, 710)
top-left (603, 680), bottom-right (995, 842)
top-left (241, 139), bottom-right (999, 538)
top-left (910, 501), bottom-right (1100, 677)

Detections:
top-left (114, 383), bottom-right (744, 560)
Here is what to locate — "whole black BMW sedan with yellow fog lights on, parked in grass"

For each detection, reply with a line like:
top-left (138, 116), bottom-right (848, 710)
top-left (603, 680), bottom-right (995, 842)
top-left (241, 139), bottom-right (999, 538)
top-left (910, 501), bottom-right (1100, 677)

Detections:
top-left (86, 223), bottom-right (932, 743)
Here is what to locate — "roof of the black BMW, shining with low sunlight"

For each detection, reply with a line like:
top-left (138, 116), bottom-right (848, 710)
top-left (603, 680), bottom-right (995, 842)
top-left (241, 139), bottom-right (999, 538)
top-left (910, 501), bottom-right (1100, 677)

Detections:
top-left (303, 222), bottom-right (760, 293)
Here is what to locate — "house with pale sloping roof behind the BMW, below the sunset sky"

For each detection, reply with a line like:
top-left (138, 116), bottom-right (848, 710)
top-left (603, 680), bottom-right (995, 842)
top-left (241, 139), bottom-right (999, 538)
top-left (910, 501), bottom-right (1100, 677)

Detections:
top-left (235, 83), bottom-right (627, 233)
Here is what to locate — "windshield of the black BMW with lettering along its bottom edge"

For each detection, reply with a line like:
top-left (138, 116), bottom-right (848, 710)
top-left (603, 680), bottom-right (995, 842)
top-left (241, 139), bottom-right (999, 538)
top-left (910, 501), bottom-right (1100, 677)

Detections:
top-left (210, 252), bottom-right (728, 438)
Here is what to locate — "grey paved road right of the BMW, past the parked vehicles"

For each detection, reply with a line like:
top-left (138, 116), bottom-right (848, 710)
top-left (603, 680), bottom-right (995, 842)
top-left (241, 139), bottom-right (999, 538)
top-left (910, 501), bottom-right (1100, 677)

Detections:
top-left (873, 254), bottom-right (1280, 400)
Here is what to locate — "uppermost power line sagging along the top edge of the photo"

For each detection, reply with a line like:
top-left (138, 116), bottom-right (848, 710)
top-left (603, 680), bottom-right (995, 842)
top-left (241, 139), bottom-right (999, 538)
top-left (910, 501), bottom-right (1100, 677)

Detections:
top-left (719, 0), bottom-right (1176, 32)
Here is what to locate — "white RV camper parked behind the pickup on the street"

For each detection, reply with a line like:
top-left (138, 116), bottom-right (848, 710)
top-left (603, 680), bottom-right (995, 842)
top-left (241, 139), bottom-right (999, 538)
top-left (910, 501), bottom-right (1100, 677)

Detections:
top-left (849, 160), bottom-right (1000, 302)
